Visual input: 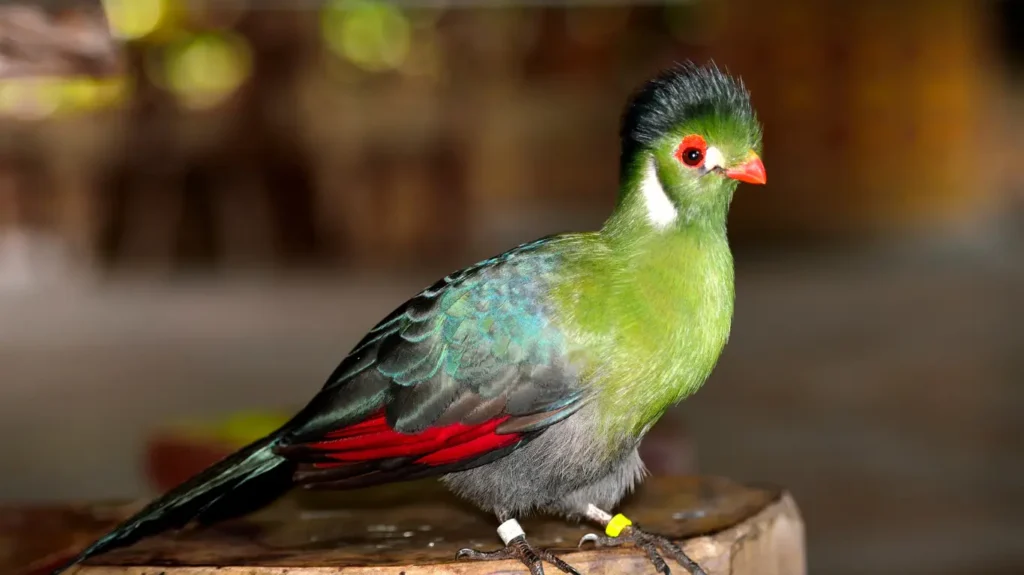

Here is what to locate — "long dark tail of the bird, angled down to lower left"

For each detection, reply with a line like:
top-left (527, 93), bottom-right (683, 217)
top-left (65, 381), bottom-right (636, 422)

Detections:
top-left (52, 436), bottom-right (294, 575)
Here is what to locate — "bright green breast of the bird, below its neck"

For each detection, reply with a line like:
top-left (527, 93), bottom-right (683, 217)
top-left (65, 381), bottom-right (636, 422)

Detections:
top-left (556, 231), bottom-right (734, 443)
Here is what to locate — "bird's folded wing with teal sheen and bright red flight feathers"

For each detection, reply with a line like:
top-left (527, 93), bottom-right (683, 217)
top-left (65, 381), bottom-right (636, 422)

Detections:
top-left (278, 236), bottom-right (585, 488)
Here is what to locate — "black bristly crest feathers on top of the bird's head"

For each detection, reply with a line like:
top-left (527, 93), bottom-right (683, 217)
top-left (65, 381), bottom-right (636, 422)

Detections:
top-left (620, 61), bottom-right (757, 172)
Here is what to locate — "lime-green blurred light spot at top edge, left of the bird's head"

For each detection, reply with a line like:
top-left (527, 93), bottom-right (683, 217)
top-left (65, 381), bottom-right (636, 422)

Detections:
top-left (321, 0), bottom-right (412, 72)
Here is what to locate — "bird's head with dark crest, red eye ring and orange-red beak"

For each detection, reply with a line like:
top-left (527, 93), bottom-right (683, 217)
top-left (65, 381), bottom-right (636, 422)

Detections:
top-left (620, 63), bottom-right (767, 228)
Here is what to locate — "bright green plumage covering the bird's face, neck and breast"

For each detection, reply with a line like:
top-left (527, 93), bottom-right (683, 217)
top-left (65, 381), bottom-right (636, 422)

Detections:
top-left (552, 65), bottom-right (761, 449)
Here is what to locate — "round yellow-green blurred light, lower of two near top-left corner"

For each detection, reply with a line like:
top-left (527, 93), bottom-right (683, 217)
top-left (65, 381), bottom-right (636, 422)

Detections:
top-left (164, 34), bottom-right (252, 108)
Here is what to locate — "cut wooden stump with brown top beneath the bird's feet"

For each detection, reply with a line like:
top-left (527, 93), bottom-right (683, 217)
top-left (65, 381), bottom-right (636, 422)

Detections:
top-left (6, 478), bottom-right (806, 575)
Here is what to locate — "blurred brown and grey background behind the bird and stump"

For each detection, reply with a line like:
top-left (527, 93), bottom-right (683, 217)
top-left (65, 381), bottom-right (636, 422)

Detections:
top-left (0, 0), bottom-right (1024, 575)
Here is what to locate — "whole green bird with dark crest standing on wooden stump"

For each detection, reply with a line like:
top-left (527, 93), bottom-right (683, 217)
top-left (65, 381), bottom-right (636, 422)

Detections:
top-left (53, 60), bottom-right (767, 575)
